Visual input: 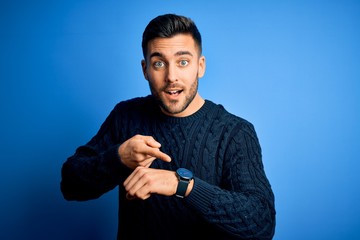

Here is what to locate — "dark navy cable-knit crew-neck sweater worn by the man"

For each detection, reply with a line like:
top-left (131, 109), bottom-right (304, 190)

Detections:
top-left (61, 96), bottom-right (275, 240)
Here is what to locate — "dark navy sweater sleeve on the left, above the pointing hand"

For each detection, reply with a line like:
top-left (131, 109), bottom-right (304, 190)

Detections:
top-left (60, 106), bottom-right (129, 201)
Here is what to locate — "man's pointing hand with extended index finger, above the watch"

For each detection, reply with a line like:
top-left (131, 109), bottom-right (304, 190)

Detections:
top-left (118, 135), bottom-right (171, 169)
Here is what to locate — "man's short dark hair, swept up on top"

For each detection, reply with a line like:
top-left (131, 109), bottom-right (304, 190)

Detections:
top-left (142, 14), bottom-right (202, 60)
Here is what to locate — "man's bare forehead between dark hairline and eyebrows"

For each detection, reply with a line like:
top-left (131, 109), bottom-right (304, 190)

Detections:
top-left (147, 34), bottom-right (198, 57)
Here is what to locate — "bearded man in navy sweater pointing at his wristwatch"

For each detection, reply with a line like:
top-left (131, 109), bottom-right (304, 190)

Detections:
top-left (61, 14), bottom-right (275, 239)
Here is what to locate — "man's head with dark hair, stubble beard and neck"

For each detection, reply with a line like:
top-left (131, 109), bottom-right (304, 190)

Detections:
top-left (141, 14), bottom-right (206, 117)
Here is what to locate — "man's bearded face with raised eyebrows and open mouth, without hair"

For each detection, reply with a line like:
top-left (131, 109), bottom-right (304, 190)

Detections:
top-left (142, 34), bottom-right (205, 117)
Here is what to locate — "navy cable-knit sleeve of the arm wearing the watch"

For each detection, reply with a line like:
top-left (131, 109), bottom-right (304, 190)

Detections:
top-left (186, 123), bottom-right (275, 239)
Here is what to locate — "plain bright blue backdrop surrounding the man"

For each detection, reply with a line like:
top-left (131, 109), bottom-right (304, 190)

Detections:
top-left (0, 0), bottom-right (360, 240)
